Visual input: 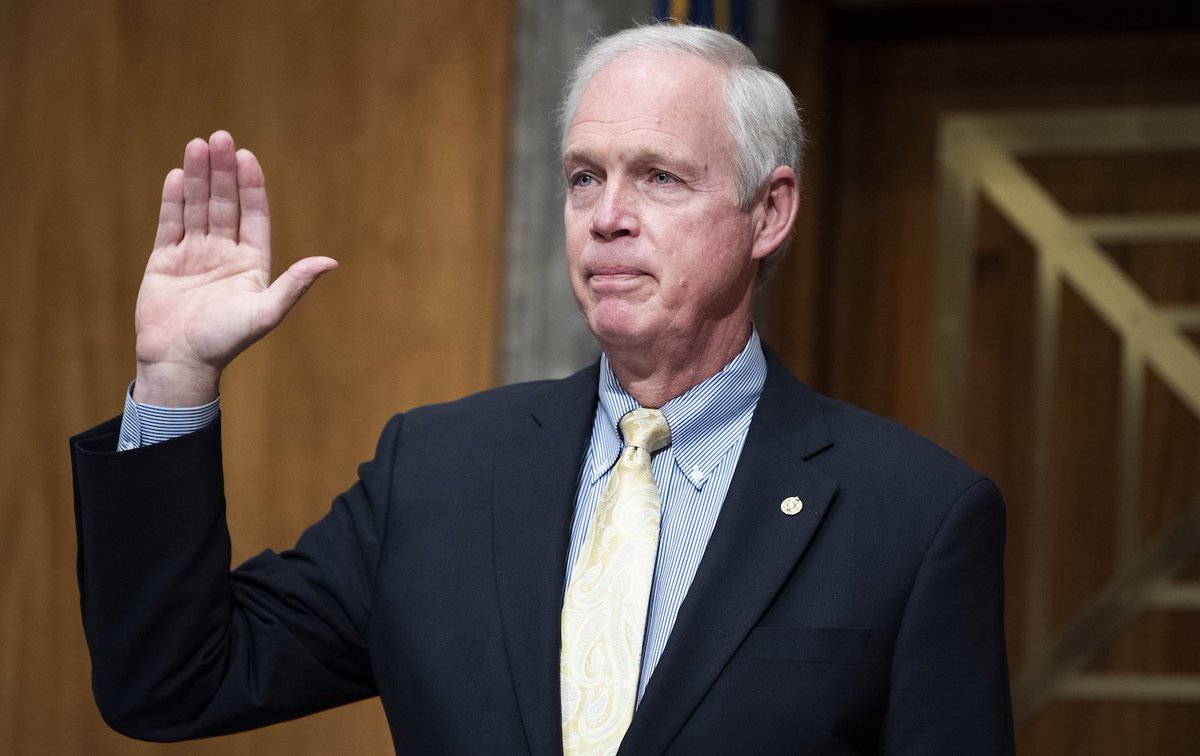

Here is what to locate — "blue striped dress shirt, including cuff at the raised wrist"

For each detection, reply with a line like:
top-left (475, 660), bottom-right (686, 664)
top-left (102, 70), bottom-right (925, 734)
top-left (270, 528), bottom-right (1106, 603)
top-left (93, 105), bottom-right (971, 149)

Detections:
top-left (118, 331), bottom-right (767, 701)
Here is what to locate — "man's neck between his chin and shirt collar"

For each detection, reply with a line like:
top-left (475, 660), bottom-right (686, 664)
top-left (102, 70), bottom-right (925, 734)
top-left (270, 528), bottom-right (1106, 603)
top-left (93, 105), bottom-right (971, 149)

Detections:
top-left (604, 318), bottom-right (750, 409)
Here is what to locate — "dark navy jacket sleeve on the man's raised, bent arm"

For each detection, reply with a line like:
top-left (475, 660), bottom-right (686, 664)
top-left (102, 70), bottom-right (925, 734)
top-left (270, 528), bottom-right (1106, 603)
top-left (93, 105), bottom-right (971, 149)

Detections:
top-left (71, 418), bottom-right (401, 740)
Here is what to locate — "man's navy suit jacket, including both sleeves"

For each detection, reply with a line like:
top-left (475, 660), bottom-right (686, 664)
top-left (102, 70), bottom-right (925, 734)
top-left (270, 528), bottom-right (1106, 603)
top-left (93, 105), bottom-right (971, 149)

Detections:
top-left (72, 354), bottom-right (1013, 755)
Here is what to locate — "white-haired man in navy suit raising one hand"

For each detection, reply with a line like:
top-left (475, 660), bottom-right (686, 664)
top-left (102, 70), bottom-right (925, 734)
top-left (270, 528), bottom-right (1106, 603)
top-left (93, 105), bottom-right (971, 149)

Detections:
top-left (72, 26), bottom-right (1013, 754)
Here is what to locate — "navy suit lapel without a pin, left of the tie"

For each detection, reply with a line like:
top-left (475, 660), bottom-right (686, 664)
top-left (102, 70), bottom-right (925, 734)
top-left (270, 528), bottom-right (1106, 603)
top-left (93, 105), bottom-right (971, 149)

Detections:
top-left (493, 366), bottom-right (598, 754)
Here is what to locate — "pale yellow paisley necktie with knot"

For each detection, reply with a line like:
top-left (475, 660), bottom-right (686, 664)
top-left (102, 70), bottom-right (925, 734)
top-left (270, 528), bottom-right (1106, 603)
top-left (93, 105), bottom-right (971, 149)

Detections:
top-left (560, 409), bottom-right (671, 756)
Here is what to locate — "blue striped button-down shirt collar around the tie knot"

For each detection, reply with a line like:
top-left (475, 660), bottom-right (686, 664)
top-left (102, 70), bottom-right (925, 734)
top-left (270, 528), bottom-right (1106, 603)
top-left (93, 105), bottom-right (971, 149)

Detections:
top-left (589, 330), bottom-right (767, 488)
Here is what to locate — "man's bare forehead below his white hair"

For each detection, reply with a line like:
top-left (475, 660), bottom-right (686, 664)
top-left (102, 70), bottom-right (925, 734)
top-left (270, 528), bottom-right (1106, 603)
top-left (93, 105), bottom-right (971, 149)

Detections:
top-left (565, 54), bottom-right (728, 159)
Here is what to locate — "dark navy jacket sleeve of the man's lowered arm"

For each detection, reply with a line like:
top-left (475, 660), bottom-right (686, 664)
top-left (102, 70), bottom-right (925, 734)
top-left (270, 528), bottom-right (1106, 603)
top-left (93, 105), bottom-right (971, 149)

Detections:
top-left (881, 480), bottom-right (1014, 755)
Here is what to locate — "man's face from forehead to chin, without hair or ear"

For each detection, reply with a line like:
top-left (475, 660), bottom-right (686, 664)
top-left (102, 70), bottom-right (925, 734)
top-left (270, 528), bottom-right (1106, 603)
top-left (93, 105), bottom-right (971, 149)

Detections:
top-left (563, 55), bottom-right (764, 352)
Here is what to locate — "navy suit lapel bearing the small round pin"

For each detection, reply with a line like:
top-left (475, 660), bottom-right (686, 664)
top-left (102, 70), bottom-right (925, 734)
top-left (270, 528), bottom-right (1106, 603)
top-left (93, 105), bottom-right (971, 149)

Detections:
top-left (620, 350), bottom-right (838, 754)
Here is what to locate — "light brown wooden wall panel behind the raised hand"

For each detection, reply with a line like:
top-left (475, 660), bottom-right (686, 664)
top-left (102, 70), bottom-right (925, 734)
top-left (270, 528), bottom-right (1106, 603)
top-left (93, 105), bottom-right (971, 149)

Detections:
top-left (0, 0), bottom-right (512, 754)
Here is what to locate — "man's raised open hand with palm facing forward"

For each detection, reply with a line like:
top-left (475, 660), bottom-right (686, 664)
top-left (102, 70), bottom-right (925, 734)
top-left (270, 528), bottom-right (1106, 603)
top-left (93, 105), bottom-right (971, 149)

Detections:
top-left (133, 131), bottom-right (337, 407)
